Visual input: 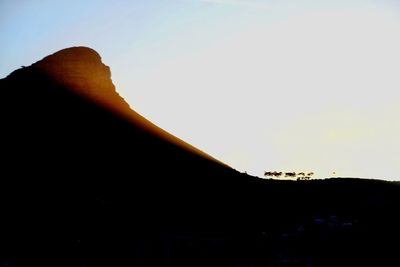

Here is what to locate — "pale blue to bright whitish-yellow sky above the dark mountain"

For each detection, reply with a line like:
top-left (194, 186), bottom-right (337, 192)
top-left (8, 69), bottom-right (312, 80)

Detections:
top-left (0, 0), bottom-right (400, 180)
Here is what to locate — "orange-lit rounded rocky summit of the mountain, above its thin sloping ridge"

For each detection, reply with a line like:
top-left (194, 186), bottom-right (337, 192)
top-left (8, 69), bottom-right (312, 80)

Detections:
top-left (32, 47), bottom-right (132, 119)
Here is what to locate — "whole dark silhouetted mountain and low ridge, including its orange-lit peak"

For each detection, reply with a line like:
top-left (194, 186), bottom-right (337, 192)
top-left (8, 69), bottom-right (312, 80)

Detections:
top-left (0, 47), bottom-right (400, 267)
